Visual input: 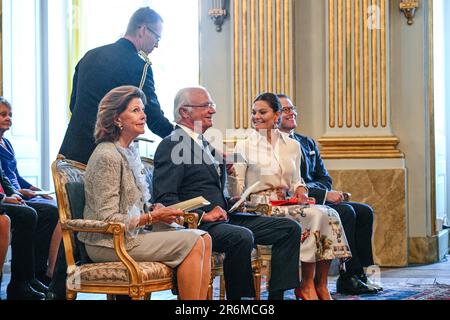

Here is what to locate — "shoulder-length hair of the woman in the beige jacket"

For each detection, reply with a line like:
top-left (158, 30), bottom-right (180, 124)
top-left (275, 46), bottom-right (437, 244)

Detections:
top-left (94, 86), bottom-right (147, 144)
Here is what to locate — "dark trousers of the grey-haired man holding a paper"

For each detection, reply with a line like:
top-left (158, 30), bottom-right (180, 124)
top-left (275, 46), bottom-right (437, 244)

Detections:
top-left (205, 216), bottom-right (301, 299)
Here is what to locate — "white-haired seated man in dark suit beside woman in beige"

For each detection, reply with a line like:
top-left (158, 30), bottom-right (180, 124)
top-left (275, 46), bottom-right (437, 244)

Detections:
top-left (153, 87), bottom-right (301, 300)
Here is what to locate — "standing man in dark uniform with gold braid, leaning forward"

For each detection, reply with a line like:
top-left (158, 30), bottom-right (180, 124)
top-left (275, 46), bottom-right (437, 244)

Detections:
top-left (59, 7), bottom-right (173, 164)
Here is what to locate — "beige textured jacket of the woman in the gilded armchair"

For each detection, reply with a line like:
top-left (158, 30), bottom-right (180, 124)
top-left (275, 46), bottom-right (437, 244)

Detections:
top-left (78, 142), bottom-right (144, 250)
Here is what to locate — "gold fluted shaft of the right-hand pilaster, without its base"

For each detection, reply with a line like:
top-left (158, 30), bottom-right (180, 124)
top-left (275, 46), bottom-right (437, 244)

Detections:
top-left (328, 0), bottom-right (390, 129)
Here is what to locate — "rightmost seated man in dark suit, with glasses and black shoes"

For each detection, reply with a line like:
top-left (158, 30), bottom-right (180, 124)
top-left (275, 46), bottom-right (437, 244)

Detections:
top-left (278, 95), bottom-right (382, 294)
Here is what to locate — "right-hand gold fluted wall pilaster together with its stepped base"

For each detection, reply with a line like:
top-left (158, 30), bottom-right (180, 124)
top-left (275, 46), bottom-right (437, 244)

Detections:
top-left (319, 0), bottom-right (404, 159)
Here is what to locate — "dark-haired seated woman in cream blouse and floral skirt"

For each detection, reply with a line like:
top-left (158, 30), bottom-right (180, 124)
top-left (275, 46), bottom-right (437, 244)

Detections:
top-left (228, 93), bottom-right (351, 300)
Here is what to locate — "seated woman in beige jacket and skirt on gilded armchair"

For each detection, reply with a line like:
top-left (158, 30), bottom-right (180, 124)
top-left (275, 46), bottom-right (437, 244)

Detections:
top-left (78, 86), bottom-right (211, 300)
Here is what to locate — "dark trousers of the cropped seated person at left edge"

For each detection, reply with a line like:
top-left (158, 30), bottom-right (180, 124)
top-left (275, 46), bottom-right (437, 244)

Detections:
top-left (1, 201), bottom-right (58, 283)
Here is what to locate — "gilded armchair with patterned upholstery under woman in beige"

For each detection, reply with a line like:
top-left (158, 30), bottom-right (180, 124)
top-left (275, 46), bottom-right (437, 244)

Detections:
top-left (52, 155), bottom-right (172, 300)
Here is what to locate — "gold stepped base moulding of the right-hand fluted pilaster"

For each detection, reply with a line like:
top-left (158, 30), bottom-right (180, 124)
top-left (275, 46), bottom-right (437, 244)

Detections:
top-left (318, 137), bottom-right (405, 159)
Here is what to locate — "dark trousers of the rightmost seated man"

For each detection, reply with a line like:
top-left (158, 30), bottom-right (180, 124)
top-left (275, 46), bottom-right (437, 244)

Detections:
top-left (327, 202), bottom-right (374, 276)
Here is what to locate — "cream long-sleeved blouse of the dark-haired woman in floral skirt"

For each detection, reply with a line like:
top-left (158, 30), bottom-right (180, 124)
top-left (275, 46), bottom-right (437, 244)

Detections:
top-left (228, 130), bottom-right (306, 196)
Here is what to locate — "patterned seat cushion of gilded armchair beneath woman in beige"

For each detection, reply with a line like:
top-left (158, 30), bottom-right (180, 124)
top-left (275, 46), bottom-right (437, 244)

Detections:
top-left (67, 262), bottom-right (172, 290)
